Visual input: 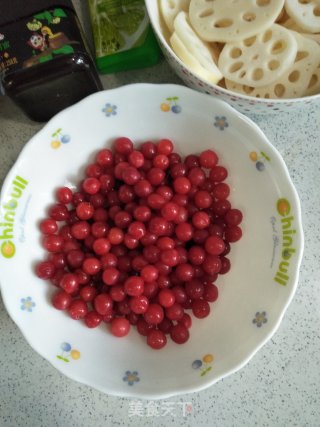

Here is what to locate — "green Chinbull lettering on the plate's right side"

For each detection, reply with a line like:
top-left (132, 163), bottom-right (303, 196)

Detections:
top-left (274, 199), bottom-right (296, 286)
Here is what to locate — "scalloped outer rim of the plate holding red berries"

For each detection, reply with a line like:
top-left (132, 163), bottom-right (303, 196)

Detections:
top-left (0, 83), bottom-right (304, 400)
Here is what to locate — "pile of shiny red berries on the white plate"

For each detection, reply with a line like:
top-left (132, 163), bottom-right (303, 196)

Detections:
top-left (36, 137), bottom-right (242, 349)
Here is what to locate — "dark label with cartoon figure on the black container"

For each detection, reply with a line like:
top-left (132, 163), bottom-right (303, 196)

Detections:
top-left (0, 8), bottom-right (85, 73)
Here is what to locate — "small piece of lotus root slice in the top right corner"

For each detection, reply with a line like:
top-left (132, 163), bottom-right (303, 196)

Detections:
top-left (285, 0), bottom-right (320, 33)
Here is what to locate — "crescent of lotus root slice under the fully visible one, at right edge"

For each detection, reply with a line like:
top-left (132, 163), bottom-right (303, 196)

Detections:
top-left (226, 32), bottom-right (320, 99)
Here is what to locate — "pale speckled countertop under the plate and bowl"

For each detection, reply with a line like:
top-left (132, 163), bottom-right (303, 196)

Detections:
top-left (0, 2), bottom-right (320, 427)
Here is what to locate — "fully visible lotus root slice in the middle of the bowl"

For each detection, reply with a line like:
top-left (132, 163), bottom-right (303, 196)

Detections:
top-left (218, 24), bottom-right (297, 87)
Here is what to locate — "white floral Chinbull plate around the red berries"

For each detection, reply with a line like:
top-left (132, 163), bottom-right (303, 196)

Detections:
top-left (0, 84), bottom-right (303, 399)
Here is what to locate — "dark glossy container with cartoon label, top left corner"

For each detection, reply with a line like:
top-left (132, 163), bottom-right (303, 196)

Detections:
top-left (0, 0), bottom-right (102, 122)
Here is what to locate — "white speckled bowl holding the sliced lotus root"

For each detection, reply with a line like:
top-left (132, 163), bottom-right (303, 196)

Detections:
top-left (145, 0), bottom-right (320, 114)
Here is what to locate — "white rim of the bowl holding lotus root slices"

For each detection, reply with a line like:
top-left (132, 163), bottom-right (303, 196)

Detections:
top-left (145, 0), bottom-right (320, 105)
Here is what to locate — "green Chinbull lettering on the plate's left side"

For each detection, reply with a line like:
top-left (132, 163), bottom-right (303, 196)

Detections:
top-left (0, 175), bottom-right (28, 258)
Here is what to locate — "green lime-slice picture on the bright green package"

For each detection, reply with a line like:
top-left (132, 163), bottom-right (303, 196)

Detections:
top-left (89, 0), bottom-right (149, 58)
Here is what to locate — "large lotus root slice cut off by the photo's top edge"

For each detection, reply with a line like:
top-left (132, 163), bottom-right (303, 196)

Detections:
top-left (189, 0), bottom-right (284, 43)
